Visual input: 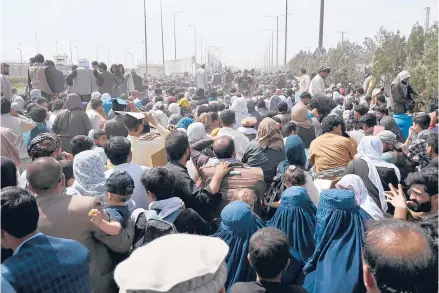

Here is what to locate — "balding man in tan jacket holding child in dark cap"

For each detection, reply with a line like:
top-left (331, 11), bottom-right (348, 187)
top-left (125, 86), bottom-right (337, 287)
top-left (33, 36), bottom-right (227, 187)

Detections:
top-left (27, 157), bottom-right (134, 293)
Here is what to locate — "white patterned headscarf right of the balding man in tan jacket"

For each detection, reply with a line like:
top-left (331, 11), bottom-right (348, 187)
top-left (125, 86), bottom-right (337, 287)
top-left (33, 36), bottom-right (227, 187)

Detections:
top-left (72, 150), bottom-right (106, 199)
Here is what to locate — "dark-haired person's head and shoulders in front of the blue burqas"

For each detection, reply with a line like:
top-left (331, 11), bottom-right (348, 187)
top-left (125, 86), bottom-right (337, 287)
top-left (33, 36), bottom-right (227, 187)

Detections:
top-left (230, 227), bottom-right (307, 293)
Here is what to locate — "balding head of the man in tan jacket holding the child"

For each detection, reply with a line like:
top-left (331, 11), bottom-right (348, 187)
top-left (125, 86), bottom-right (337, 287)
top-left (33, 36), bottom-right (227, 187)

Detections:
top-left (26, 157), bottom-right (63, 193)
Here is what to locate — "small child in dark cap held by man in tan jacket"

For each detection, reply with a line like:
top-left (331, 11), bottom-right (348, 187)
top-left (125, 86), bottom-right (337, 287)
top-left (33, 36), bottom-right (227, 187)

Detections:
top-left (89, 171), bottom-right (134, 235)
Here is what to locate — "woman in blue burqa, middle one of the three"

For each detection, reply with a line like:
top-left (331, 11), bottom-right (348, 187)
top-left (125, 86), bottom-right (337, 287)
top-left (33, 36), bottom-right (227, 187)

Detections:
top-left (267, 186), bottom-right (316, 285)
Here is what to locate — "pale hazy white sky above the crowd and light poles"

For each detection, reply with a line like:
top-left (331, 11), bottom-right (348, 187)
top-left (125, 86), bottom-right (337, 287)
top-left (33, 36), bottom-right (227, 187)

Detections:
top-left (0, 0), bottom-right (438, 67)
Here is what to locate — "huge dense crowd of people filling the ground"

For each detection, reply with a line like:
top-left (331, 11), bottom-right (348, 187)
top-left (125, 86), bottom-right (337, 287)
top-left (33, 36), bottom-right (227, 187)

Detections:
top-left (0, 54), bottom-right (439, 293)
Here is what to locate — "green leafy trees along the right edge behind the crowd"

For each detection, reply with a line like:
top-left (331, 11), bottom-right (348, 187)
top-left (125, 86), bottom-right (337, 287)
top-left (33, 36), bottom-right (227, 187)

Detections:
top-left (289, 23), bottom-right (438, 108)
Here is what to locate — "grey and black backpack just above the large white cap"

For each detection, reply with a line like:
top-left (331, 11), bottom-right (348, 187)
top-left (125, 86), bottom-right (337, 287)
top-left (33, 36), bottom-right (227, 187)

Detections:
top-left (131, 208), bottom-right (182, 251)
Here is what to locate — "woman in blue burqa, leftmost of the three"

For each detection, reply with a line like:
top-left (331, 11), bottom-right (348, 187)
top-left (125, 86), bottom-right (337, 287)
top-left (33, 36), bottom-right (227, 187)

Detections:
top-left (212, 200), bottom-right (262, 292)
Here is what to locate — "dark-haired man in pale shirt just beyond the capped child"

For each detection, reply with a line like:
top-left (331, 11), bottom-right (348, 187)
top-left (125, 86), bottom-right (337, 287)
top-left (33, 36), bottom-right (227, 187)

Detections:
top-left (104, 136), bottom-right (149, 209)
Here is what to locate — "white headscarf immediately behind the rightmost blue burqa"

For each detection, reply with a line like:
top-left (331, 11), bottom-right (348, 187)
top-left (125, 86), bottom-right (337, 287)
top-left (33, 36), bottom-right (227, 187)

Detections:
top-left (335, 174), bottom-right (384, 220)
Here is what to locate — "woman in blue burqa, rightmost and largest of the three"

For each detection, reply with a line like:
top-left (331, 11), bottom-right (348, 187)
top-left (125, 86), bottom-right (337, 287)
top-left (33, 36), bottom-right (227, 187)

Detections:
top-left (303, 189), bottom-right (370, 293)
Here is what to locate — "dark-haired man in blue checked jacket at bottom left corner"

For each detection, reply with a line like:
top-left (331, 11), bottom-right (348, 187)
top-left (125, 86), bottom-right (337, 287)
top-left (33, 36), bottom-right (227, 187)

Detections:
top-left (0, 186), bottom-right (93, 293)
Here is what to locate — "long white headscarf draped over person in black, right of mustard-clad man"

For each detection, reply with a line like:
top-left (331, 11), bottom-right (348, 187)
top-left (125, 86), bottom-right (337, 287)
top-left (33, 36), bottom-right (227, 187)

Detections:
top-left (355, 136), bottom-right (401, 212)
